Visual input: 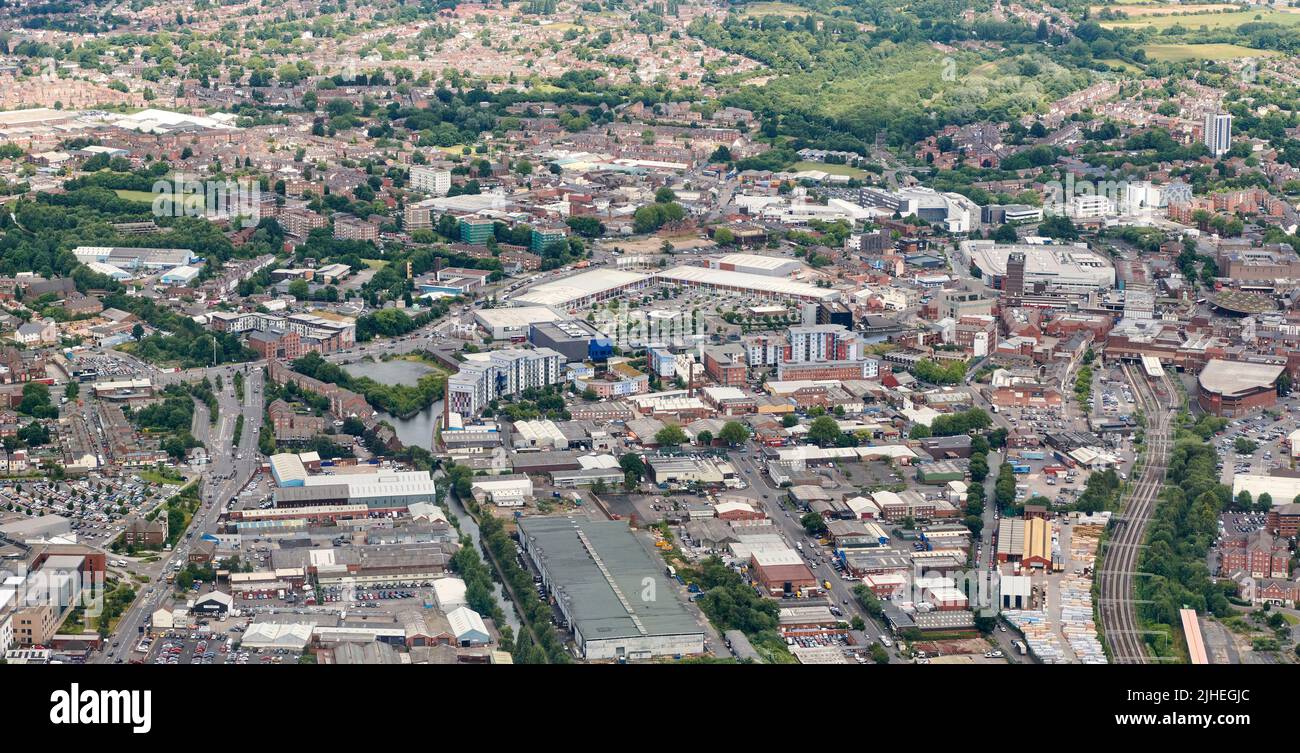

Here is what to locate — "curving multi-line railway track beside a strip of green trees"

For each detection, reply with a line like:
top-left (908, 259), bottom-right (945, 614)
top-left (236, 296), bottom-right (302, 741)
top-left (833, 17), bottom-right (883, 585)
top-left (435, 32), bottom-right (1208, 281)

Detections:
top-left (1100, 364), bottom-right (1174, 665)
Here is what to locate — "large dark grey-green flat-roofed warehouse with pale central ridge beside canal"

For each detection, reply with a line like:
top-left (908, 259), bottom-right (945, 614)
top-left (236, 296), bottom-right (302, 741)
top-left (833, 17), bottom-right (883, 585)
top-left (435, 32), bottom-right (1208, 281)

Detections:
top-left (519, 516), bottom-right (703, 659)
